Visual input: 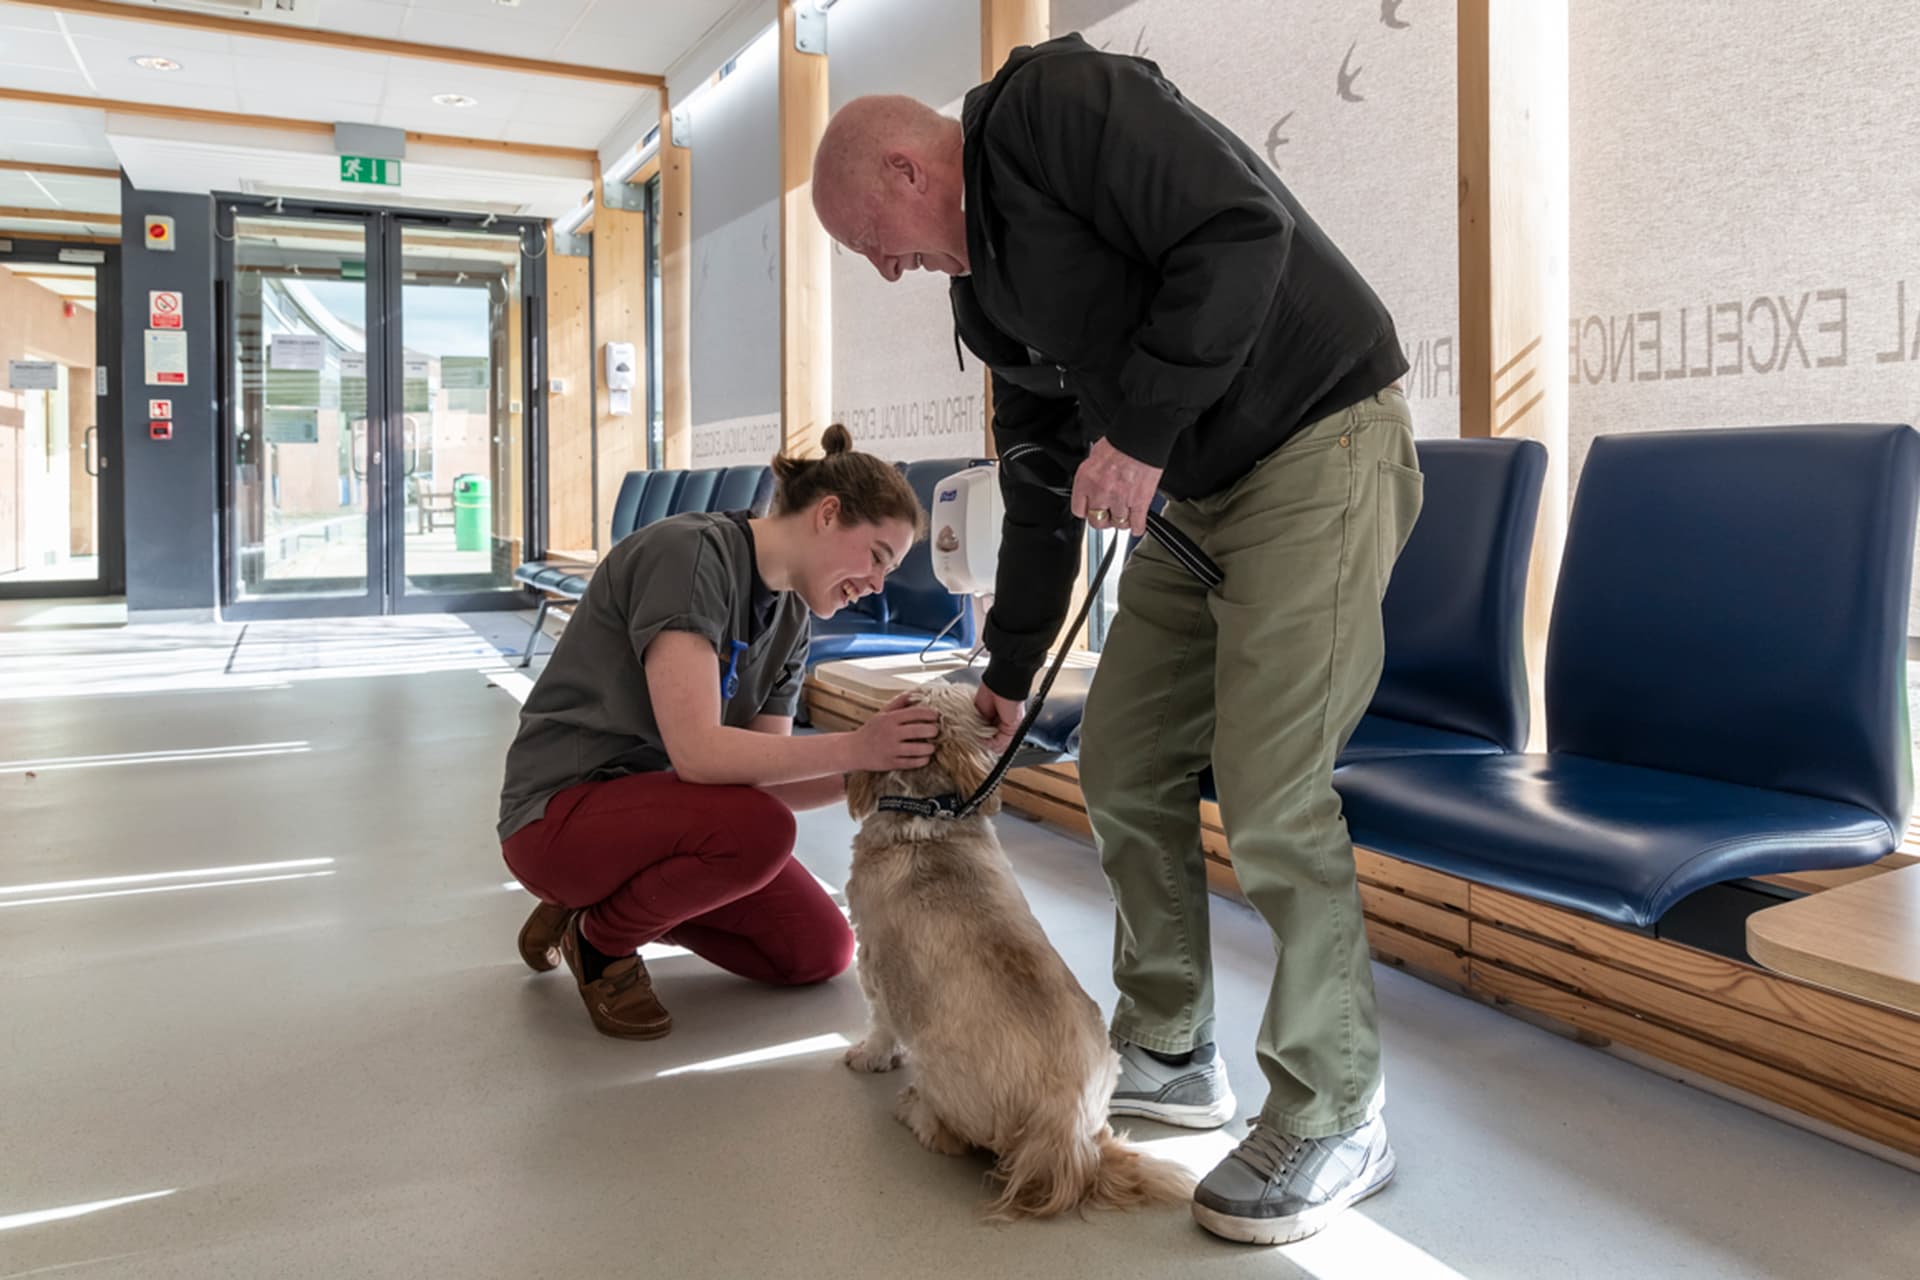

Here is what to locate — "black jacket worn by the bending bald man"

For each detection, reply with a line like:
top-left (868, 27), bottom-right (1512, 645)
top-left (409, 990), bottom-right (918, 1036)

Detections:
top-left (952, 35), bottom-right (1407, 697)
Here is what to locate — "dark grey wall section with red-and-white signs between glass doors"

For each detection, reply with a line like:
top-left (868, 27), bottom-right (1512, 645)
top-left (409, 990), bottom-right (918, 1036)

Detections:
top-left (121, 180), bottom-right (219, 618)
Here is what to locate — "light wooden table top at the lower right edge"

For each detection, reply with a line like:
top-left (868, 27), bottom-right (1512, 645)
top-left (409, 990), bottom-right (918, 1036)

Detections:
top-left (1747, 865), bottom-right (1920, 1013)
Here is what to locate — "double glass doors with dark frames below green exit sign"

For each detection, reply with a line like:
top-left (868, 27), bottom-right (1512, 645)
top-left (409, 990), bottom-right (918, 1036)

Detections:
top-left (221, 198), bottom-right (545, 618)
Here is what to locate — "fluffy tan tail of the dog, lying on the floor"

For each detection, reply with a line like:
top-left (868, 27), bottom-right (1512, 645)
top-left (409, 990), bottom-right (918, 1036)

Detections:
top-left (987, 1115), bottom-right (1194, 1222)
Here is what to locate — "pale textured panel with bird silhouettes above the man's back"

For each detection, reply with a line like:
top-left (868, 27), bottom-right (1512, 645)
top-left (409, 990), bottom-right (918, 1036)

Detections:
top-left (1052, 0), bottom-right (1459, 436)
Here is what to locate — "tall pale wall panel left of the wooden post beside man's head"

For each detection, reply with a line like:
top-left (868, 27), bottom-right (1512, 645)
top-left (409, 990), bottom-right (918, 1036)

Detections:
top-left (687, 25), bottom-right (780, 466)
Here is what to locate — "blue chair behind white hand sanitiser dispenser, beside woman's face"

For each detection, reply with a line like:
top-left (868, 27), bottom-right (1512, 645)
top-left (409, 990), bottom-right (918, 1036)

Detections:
top-left (806, 459), bottom-right (975, 666)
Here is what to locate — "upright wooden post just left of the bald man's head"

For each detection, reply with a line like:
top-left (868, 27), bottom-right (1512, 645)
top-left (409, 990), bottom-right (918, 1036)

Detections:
top-left (780, 0), bottom-right (833, 455)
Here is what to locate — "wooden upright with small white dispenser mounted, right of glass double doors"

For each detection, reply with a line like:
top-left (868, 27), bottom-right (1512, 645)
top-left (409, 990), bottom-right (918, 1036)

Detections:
top-left (584, 165), bottom-right (649, 551)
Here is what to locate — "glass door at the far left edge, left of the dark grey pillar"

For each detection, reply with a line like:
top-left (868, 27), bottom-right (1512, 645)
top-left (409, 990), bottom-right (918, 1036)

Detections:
top-left (0, 234), bottom-right (125, 599)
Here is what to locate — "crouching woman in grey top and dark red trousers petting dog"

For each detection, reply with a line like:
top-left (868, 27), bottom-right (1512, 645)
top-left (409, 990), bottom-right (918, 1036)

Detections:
top-left (499, 426), bottom-right (935, 1040)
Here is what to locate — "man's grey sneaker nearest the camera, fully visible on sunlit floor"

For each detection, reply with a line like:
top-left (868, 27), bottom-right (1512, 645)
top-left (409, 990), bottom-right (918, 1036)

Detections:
top-left (1194, 1117), bottom-right (1394, 1244)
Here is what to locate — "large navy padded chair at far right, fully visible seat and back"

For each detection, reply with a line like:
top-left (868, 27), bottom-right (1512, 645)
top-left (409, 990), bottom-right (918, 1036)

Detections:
top-left (1336, 426), bottom-right (1920, 927)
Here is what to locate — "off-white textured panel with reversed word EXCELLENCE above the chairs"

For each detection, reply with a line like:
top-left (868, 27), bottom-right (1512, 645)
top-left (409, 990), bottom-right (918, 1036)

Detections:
top-left (1569, 0), bottom-right (1920, 631)
